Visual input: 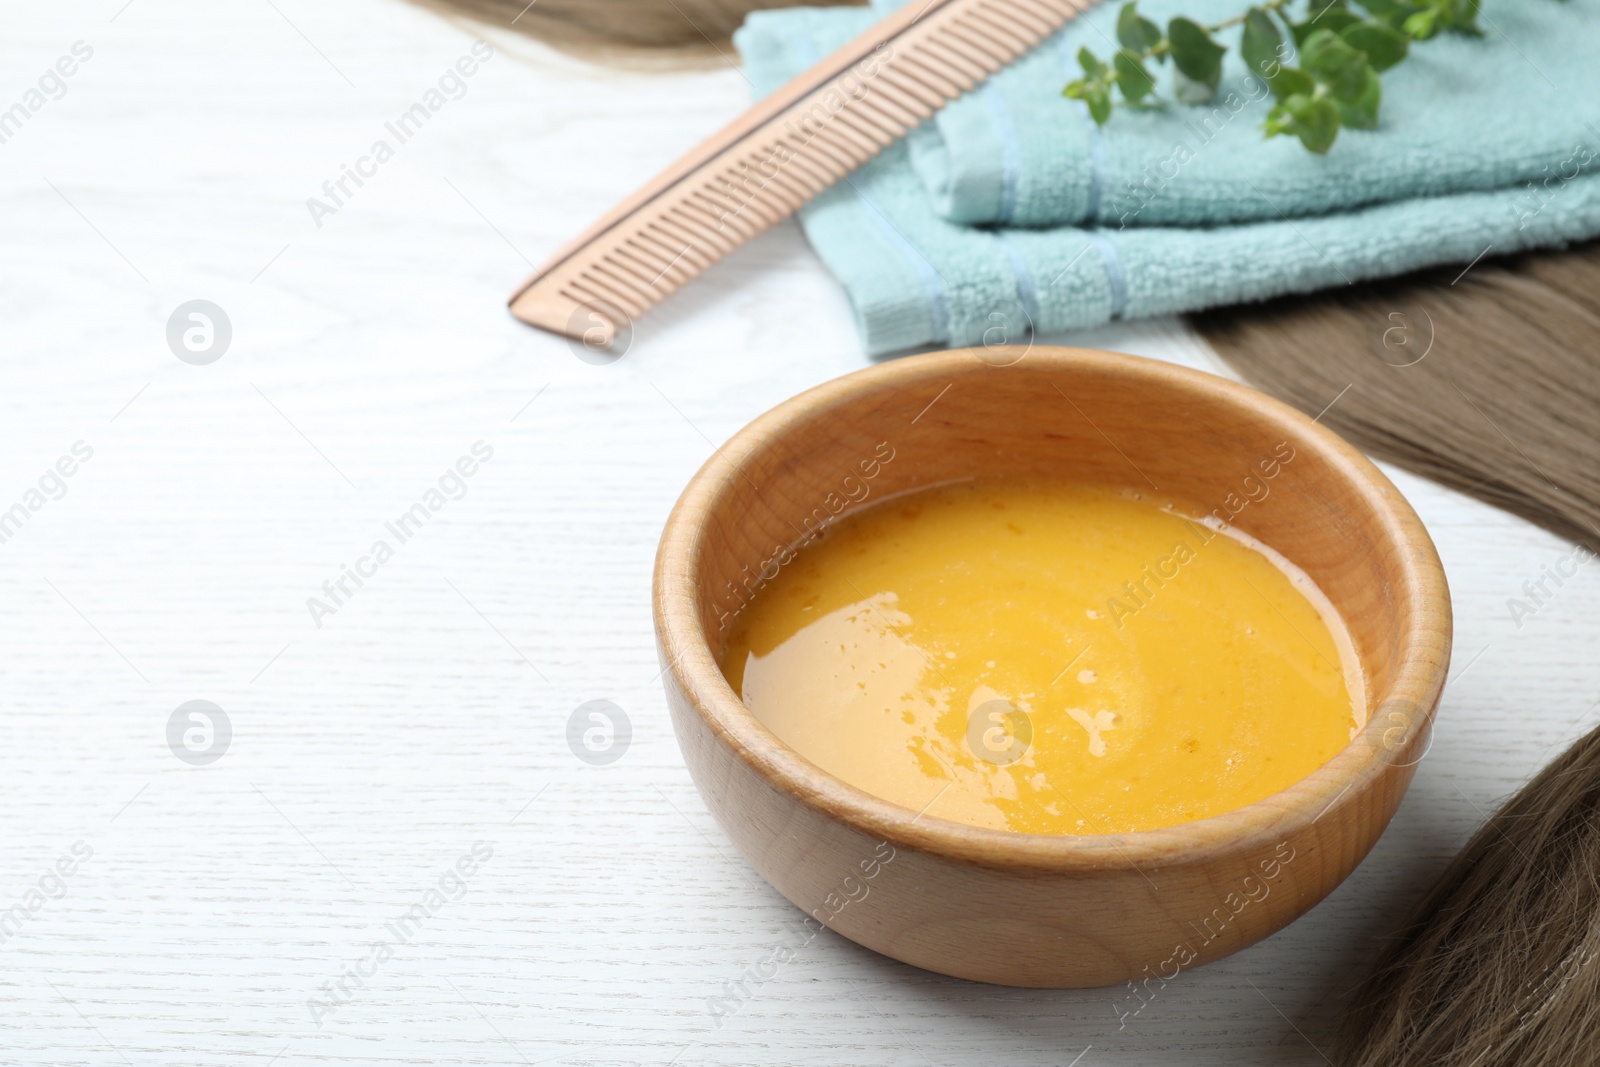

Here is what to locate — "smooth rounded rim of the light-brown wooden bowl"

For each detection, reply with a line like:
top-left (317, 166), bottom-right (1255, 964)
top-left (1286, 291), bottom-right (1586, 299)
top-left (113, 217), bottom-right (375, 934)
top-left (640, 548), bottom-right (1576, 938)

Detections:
top-left (653, 346), bottom-right (1451, 873)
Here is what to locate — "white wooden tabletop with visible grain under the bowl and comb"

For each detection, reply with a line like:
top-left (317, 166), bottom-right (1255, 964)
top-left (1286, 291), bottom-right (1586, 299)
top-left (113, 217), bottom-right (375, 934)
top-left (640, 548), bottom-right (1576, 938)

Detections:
top-left (0, 0), bottom-right (1600, 1067)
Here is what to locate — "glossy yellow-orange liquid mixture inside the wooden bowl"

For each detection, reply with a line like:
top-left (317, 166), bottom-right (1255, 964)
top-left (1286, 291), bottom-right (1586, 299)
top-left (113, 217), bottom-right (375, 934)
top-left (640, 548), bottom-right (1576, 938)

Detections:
top-left (723, 482), bottom-right (1366, 833)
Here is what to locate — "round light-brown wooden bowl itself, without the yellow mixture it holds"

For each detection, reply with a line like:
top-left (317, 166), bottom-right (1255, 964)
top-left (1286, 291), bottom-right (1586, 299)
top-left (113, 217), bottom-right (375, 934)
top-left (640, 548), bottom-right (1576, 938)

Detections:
top-left (654, 347), bottom-right (1450, 990)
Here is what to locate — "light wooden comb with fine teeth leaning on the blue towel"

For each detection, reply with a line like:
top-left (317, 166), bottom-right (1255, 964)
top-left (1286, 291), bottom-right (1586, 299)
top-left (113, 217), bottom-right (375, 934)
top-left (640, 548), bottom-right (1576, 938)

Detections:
top-left (510, 0), bottom-right (1096, 347)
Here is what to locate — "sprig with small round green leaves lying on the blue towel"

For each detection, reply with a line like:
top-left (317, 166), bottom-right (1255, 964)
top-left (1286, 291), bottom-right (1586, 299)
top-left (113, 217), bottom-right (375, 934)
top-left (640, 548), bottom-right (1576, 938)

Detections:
top-left (1062, 0), bottom-right (1482, 154)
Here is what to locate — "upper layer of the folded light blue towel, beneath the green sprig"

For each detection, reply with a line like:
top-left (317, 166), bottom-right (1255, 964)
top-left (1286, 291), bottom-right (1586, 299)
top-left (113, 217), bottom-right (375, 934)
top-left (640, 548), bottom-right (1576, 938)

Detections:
top-left (739, 0), bottom-right (1600, 227)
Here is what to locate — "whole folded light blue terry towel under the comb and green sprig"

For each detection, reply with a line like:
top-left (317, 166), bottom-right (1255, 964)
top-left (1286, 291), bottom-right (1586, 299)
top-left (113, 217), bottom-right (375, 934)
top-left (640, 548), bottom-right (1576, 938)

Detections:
top-left (734, 0), bottom-right (1600, 354)
